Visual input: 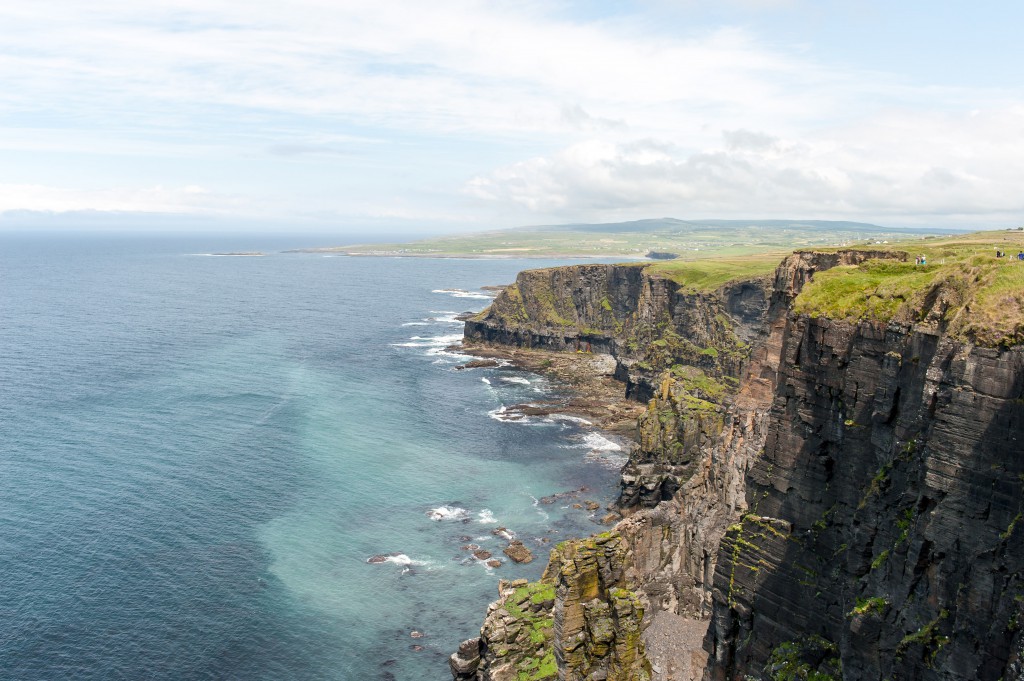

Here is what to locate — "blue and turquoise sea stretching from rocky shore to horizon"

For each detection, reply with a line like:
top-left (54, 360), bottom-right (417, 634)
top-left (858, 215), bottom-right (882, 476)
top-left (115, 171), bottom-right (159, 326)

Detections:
top-left (0, 236), bottom-right (621, 681)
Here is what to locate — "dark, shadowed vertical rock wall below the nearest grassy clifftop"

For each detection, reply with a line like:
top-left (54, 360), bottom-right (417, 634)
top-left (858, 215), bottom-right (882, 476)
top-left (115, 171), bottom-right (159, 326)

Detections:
top-left (709, 317), bottom-right (1024, 681)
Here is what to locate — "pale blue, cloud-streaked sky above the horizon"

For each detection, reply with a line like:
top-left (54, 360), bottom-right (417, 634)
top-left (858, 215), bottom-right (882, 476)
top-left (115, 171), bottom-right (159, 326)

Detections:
top-left (0, 0), bottom-right (1024, 235)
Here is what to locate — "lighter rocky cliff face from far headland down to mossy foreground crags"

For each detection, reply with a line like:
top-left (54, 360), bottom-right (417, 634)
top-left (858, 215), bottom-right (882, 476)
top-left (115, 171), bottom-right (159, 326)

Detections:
top-left (452, 260), bottom-right (769, 681)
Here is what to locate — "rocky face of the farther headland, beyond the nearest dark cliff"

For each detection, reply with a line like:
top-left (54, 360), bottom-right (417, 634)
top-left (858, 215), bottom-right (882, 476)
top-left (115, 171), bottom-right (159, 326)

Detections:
top-left (465, 265), bottom-right (769, 399)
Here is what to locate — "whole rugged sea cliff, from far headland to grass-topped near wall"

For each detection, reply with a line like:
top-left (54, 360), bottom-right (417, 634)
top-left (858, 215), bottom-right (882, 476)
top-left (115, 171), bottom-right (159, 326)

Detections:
top-left (453, 235), bottom-right (1024, 681)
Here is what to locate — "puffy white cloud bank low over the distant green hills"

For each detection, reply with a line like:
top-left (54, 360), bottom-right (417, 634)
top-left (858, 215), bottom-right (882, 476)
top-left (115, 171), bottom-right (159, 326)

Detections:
top-left (466, 104), bottom-right (1024, 221)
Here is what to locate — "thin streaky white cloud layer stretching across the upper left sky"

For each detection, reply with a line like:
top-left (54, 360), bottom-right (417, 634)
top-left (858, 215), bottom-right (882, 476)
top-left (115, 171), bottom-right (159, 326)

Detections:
top-left (0, 0), bottom-right (872, 138)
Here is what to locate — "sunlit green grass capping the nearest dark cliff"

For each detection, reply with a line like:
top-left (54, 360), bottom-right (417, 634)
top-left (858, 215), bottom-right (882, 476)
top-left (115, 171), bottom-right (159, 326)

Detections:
top-left (794, 230), bottom-right (1024, 346)
